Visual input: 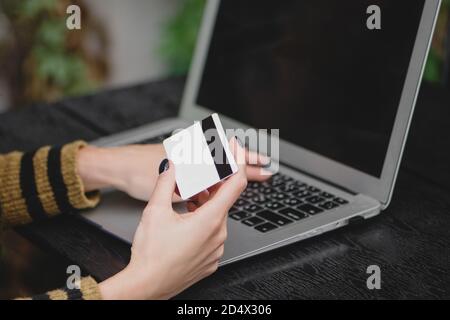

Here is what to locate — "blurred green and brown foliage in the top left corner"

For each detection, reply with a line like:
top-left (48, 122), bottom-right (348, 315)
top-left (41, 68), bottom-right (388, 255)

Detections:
top-left (0, 0), bottom-right (107, 104)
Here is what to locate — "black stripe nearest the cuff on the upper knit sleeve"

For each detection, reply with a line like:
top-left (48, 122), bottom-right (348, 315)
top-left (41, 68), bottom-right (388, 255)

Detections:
top-left (47, 147), bottom-right (75, 213)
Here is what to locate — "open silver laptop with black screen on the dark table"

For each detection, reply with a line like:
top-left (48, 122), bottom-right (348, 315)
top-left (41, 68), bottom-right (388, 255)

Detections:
top-left (83, 0), bottom-right (440, 265)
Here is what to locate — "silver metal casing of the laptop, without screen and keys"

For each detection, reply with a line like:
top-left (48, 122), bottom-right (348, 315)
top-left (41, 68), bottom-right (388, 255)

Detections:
top-left (83, 0), bottom-right (440, 265)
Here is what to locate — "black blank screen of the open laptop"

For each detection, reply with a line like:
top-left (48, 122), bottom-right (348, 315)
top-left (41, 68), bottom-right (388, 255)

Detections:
top-left (196, 0), bottom-right (425, 178)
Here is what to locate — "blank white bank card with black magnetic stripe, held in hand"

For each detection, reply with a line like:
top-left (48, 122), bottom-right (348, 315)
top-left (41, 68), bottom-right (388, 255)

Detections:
top-left (163, 114), bottom-right (238, 200)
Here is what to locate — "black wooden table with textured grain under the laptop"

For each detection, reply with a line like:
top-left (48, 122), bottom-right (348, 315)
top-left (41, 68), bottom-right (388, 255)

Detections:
top-left (0, 79), bottom-right (450, 299)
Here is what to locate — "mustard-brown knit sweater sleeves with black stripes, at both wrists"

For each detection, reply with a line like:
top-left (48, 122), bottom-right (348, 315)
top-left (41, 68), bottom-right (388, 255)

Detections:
top-left (0, 141), bottom-right (101, 299)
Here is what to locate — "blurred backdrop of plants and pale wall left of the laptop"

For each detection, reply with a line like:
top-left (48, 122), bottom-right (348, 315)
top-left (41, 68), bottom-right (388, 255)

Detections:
top-left (0, 0), bottom-right (205, 112)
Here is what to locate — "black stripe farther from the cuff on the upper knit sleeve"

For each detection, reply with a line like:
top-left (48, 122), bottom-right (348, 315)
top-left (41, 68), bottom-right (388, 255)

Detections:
top-left (20, 151), bottom-right (47, 221)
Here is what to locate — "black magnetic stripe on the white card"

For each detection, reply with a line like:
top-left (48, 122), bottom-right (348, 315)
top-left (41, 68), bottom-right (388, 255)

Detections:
top-left (202, 116), bottom-right (233, 180)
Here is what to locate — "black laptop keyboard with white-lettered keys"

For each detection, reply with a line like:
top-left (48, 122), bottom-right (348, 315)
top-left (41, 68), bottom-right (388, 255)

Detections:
top-left (229, 173), bottom-right (348, 233)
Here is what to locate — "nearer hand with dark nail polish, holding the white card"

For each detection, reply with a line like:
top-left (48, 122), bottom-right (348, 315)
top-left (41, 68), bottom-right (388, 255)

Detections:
top-left (100, 141), bottom-right (247, 299)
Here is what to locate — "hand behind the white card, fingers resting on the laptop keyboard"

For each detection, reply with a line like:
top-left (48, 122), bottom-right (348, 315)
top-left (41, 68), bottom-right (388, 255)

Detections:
top-left (77, 144), bottom-right (271, 202)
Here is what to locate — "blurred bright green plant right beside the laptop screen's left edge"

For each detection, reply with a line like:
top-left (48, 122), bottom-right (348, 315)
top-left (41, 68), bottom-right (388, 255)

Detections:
top-left (159, 0), bottom-right (206, 75)
